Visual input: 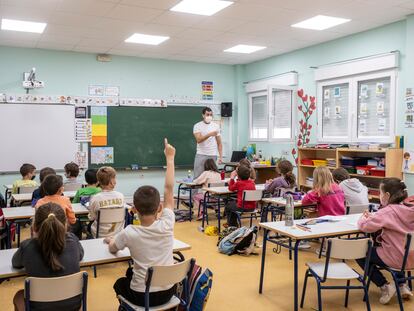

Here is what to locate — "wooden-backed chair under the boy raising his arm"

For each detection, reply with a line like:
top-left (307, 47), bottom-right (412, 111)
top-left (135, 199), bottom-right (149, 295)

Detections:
top-left (118, 259), bottom-right (195, 311)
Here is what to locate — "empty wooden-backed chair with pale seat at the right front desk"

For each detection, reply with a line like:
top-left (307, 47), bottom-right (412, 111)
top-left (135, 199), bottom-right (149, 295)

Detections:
top-left (300, 238), bottom-right (372, 311)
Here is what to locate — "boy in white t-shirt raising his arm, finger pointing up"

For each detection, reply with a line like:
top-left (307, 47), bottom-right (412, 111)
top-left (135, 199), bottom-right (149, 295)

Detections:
top-left (105, 139), bottom-right (176, 307)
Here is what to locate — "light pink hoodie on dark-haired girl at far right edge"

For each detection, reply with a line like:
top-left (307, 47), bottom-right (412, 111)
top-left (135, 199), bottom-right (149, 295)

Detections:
top-left (358, 204), bottom-right (414, 269)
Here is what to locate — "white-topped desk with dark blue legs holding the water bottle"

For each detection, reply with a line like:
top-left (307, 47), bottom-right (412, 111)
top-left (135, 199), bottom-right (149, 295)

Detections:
top-left (259, 214), bottom-right (362, 311)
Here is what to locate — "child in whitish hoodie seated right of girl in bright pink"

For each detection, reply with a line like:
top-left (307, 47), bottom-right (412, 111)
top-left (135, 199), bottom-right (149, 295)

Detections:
top-left (332, 167), bottom-right (369, 206)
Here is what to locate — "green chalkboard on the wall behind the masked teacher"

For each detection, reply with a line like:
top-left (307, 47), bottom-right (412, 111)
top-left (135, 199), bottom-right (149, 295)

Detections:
top-left (90, 106), bottom-right (202, 169)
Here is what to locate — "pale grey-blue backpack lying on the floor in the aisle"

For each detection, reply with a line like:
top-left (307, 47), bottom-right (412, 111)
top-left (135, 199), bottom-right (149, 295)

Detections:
top-left (218, 226), bottom-right (257, 256)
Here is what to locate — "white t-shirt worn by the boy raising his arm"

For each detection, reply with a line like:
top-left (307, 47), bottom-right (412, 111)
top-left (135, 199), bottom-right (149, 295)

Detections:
top-left (115, 208), bottom-right (175, 292)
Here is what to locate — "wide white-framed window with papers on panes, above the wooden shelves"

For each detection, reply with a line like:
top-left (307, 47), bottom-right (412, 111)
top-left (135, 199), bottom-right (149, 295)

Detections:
top-left (318, 70), bottom-right (396, 143)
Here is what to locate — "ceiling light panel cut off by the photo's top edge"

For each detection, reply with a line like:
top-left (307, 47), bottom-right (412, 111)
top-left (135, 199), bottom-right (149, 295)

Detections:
top-left (170, 0), bottom-right (233, 16)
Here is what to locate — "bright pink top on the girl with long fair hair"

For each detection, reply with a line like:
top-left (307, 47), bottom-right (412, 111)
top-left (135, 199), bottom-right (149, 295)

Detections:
top-left (302, 184), bottom-right (346, 217)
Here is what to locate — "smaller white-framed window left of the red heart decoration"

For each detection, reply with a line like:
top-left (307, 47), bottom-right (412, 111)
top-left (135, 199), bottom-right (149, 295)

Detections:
top-left (249, 86), bottom-right (295, 141)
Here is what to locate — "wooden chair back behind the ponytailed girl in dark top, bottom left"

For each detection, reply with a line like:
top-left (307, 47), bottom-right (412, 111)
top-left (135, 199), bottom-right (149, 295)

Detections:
top-left (24, 271), bottom-right (88, 311)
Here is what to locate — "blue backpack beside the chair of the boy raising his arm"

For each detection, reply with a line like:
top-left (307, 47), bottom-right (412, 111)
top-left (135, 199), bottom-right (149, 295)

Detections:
top-left (189, 269), bottom-right (213, 311)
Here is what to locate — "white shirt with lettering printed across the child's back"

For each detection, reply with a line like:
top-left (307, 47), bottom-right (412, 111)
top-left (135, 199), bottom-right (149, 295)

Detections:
top-left (88, 190), bottom-right (125, 238)
